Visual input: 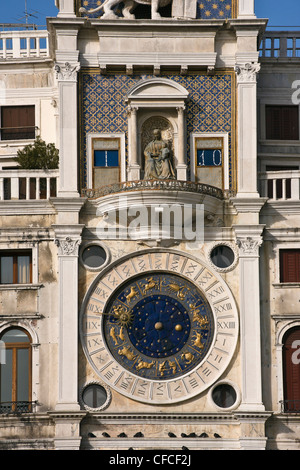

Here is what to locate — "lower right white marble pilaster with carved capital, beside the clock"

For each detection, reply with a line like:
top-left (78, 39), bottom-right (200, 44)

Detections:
top-left (234, 225), bottom-right (264, 412)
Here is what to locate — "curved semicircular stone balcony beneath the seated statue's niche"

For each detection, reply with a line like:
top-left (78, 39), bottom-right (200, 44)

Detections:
top-left (81, 180), bottom-right (226, 241)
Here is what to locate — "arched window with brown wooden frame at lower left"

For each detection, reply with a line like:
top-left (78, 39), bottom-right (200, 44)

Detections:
top-left (0, 328), bottom-right (32, 413)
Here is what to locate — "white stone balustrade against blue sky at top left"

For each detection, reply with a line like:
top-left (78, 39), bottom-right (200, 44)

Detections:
top-left (0, 30), bottom-right (50, 60)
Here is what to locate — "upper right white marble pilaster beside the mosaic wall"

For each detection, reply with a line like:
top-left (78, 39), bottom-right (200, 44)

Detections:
top-left (236, 62), bottom-right (260, 198)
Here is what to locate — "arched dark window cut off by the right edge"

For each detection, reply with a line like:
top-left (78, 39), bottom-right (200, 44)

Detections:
top-left (283, 327), bottom-right (300, 413)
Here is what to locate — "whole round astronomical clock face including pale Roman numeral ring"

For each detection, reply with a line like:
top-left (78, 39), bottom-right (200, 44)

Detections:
top-left (81, 251), bottom-right (238, 404)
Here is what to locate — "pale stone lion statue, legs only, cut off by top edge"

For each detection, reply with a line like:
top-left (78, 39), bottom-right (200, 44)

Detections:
top-left (79, 0), bottom-right (172, 19)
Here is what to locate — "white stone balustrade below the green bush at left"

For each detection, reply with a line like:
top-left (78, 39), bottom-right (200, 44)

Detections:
top-left (0, 170), bottom-right (59, 201)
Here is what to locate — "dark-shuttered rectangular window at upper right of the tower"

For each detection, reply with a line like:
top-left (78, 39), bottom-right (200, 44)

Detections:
top-left (266, 105), bottom-right (299, 140)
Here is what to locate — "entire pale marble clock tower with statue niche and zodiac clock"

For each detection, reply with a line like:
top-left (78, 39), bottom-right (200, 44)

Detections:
top-left (49, 0), bottom-right (269, 450)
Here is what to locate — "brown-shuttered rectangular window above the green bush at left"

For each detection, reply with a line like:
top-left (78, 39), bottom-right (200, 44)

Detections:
top-left (1, 106), bottom-right (35, 140)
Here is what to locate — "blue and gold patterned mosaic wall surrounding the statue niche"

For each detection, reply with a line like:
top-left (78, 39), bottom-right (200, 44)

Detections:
top-left (80, 70), bottom-right (235, 188)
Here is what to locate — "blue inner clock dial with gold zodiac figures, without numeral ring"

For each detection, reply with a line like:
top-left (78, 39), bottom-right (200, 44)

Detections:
top-left (103, 273), bottom-right (215, 380)
